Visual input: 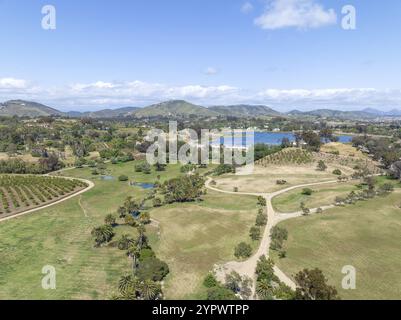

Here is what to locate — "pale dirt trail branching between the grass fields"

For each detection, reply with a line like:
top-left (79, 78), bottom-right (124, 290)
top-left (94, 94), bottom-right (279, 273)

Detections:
top-left (206, 178), bottom-right (338, 295)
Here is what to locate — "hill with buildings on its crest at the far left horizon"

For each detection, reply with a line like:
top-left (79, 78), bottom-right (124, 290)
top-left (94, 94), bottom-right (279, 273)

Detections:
top-left (0, 100), bottom-right (63, 118)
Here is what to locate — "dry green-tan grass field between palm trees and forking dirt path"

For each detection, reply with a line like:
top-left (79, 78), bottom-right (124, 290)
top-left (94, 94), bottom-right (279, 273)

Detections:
top-left (151, 192), bottom-right (258, 299)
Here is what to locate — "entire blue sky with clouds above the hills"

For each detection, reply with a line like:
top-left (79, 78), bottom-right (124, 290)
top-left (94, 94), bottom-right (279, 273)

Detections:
top-left (0, 0), bottom-right (401, 110)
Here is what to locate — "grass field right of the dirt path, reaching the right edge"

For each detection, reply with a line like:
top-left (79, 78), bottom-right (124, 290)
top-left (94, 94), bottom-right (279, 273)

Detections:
top-left (273, 189), bottom-right (401, 299)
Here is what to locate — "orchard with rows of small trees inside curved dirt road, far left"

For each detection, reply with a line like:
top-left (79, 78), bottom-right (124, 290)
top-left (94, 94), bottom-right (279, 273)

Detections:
top-left (0, 175), bottom-right (88, 218)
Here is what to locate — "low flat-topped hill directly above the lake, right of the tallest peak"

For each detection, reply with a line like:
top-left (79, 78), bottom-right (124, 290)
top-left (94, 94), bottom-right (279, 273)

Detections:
top-left (209, 104), bottom-right (281, 118)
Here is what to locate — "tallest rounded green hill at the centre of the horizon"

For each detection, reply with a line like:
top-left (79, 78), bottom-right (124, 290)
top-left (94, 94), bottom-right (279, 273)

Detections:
top-left (130, 100), bottom-right (219, 118)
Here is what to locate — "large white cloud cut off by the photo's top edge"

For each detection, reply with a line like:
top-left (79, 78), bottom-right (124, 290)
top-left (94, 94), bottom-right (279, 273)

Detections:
top-left (255, 0), bottom-right (337, 30)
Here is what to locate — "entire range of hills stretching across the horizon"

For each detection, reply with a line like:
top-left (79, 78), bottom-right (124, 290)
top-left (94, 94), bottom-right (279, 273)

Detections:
top-left (0, 100), bottom-right (401, 120)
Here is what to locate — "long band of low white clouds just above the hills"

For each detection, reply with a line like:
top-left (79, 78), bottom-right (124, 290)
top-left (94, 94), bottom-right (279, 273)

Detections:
top-left (0, 78), bottom-right (401, 111)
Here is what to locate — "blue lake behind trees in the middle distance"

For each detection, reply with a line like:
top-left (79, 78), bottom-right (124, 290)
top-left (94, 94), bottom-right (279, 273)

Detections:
top-left (213, 132), bottom-right (353, 146)
